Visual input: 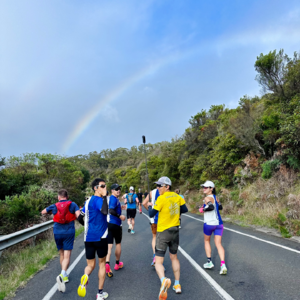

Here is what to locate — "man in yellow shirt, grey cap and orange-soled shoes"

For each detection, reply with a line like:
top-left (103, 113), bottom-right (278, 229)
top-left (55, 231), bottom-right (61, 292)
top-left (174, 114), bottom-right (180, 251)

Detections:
top-left (148, 177), bottom-right (188, 300)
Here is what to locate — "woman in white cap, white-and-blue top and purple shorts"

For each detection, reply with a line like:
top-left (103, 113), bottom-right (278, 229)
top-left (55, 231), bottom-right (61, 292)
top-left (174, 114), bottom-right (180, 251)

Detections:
top-left (199, 181), bottom-right (227, 275)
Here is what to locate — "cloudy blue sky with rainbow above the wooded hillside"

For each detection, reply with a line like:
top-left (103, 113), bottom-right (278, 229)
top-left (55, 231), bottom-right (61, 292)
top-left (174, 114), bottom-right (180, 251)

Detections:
top-left (0, 0), bottom-right (300, 157)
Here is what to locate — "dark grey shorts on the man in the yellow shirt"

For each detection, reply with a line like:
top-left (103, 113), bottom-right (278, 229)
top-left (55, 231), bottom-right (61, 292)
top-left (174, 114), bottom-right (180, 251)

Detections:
top-left (155, 226), bottom-right (179, 257)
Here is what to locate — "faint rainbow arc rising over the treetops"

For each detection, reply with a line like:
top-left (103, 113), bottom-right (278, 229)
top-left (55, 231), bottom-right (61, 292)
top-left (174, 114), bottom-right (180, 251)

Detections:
top-left (62, 53), bottom-right (187, 153)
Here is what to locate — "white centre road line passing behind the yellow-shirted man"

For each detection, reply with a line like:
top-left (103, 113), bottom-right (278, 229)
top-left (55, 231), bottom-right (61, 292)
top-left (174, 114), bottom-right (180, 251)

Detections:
top-left (143, 213), bottom-right (234, 300)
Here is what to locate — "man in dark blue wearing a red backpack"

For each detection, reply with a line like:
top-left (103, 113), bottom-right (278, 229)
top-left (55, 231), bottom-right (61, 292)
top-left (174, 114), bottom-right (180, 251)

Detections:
top-left (42, 190), bottom-right (80, 293)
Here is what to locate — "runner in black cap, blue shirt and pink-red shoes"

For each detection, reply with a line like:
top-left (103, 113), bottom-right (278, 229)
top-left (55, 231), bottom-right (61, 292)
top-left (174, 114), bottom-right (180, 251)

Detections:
top-left (105, 183), bottom-right (126, 278)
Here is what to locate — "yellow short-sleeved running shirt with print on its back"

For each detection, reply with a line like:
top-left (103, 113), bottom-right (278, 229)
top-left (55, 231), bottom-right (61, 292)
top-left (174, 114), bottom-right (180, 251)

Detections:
top-left (153, 192), bottom-right (185, 232)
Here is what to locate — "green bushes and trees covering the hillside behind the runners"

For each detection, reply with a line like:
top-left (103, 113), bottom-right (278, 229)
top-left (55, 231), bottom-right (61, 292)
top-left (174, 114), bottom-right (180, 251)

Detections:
top-left (0, 50), bottom-right (300, 237)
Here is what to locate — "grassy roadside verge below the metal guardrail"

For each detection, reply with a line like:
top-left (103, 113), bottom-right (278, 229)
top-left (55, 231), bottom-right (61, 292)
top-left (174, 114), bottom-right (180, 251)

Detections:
top-left (0, 226), bottom-right (84, 300)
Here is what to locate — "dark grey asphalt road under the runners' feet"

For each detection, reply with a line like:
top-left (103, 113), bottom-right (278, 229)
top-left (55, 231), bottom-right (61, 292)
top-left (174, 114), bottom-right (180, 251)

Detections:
top-left (14, 209), bottom-right (300, 300)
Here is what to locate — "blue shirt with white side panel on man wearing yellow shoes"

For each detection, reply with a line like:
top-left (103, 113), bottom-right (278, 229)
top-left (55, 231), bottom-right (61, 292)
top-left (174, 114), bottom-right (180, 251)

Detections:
top-left (82, 196), bottom-right (108, 242)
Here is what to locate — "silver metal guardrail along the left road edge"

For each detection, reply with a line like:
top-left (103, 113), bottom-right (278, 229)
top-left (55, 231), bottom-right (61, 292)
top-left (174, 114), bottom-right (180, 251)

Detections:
top-left (0, 220), bottom-right (54, 256)
